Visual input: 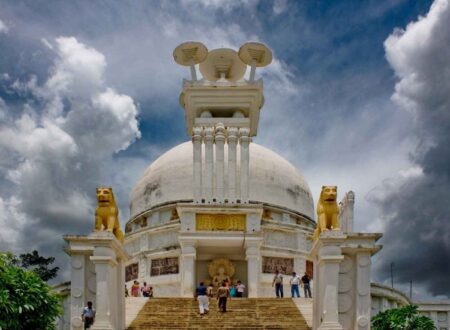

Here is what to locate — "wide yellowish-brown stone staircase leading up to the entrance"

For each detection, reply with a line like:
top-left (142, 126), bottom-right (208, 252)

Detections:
top-left (127, 298), bottom-right (312, 330)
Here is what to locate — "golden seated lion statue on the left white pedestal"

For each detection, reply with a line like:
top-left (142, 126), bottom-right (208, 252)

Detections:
top-left (95, 187), bottom-right (123, 243)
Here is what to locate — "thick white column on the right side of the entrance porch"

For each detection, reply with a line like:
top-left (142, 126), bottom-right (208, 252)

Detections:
top-left (245, 240), bottom-right (262, 298)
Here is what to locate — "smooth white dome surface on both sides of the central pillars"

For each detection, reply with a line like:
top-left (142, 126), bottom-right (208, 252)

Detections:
top-left (130, 142), bottom-right (314, 219)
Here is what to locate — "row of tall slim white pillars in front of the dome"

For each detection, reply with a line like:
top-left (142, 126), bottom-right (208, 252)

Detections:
top-left (192, 123), bottom-right (250, 203)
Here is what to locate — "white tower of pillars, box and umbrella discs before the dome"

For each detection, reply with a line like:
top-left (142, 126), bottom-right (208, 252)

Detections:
top-left (174, 42), bottom-right (272, 204)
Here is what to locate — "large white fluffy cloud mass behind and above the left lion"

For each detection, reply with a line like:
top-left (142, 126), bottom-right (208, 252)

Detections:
top-left (0, 37), bottom-right (141, 254)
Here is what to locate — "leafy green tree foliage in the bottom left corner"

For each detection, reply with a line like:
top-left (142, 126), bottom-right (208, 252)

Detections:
top-left (0, 252), bottom-right (61, 330)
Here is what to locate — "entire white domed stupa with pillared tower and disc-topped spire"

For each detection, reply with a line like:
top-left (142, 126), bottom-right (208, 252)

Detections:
top-left (121, 42), bottom-right (315, 297)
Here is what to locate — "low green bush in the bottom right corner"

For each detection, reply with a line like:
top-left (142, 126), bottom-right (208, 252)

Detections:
top-left (372, 305), bottom-right (436, 330)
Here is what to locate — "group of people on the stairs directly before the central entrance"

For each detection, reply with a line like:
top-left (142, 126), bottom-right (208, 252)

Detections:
top-left (194, 280), bottom-right (245, 315)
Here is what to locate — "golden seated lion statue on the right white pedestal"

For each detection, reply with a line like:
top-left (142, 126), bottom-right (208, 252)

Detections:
top-left (313, 186), bottom-right (340, 240)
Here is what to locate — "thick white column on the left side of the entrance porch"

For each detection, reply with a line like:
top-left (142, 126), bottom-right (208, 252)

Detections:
top-left (180, 240), bottom-right (197, 298)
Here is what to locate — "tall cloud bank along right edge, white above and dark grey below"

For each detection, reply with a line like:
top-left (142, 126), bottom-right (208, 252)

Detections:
top-left (370, 0), bottom-right (450, 298)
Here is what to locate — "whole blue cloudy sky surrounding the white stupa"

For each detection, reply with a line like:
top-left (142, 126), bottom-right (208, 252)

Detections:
top-left (0, 0), bottom-right (450, 299)
